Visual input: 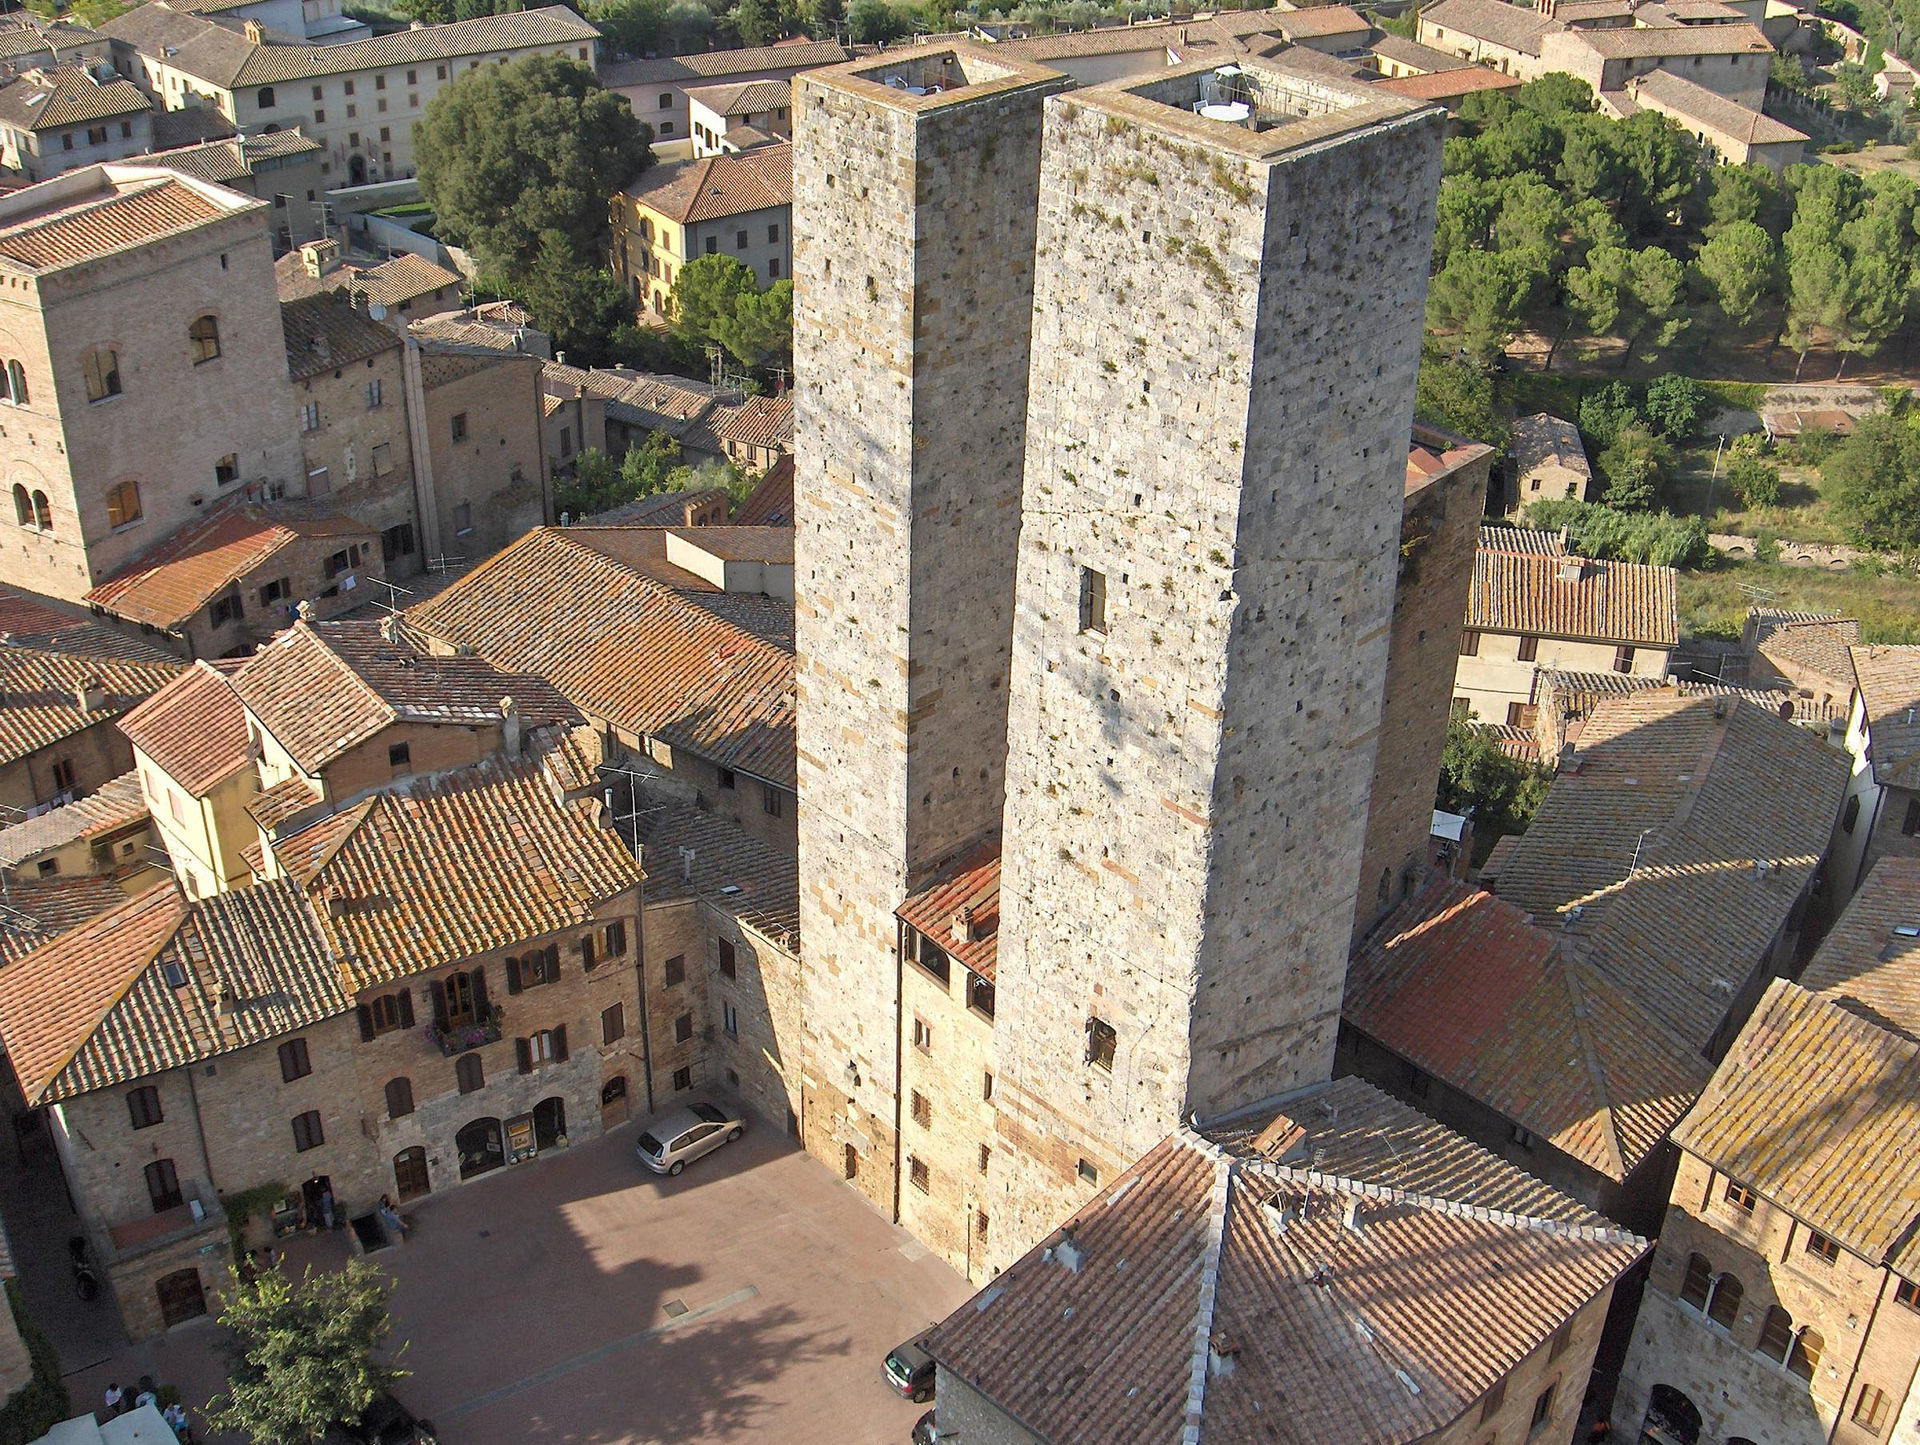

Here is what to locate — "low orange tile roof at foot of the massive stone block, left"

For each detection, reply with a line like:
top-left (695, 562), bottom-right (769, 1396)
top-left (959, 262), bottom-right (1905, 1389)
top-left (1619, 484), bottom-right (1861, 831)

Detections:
top-left (86, 505), bottom-right (376, 629)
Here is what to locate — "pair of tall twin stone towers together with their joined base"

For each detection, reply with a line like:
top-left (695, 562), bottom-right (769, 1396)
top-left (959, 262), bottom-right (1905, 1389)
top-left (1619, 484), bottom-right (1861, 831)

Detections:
top-left (793, 46), bottom-right (1446, 1278)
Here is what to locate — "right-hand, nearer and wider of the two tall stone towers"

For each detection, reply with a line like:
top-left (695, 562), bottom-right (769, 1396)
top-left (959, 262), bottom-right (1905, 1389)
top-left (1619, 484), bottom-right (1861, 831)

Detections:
top-left (987, 56), bottom-right (1444, 1253)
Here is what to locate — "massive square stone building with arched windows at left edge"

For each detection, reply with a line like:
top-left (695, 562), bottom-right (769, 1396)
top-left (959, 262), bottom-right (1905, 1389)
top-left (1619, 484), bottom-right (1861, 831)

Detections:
top-left (0, 165), bottom-right (301, 601)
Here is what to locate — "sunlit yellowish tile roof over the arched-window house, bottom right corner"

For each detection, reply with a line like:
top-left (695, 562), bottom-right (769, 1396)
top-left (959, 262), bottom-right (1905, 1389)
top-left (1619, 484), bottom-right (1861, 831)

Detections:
top-left (1674, 973), bottom-right (1920, 1278)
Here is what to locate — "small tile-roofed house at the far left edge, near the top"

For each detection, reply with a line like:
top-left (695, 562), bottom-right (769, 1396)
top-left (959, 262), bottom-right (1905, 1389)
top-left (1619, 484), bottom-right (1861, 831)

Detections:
top-left (0, 61), bottom-right (154, 180)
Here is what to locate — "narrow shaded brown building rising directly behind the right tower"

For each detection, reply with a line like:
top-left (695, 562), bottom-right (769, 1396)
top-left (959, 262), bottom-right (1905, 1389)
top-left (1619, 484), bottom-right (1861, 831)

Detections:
top-left (1354, 422), bottom-right (1494, 944)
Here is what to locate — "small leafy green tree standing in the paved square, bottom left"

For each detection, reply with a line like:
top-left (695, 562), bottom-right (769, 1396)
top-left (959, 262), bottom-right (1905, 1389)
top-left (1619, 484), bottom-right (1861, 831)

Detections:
top-left (207, 1259), bottom-right (405, 1445)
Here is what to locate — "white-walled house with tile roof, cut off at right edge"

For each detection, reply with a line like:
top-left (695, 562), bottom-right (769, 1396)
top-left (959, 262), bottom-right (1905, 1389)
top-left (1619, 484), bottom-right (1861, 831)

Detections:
top-left (1834, 645), bottom-right (1920, 898)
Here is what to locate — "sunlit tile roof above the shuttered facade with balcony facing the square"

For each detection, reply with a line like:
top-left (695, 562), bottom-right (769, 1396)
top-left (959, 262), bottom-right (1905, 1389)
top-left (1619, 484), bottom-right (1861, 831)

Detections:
top-left (273, 750), bottom-right (641, 990)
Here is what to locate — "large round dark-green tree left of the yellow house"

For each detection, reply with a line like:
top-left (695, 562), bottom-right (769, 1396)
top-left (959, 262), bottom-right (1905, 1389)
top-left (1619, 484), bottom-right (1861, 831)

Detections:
top-left (413, 56), bottom-right (653, 280)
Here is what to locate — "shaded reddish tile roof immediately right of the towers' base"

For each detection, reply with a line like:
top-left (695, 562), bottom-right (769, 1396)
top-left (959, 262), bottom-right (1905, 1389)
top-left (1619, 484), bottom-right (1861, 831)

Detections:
top-left (1342, 877), bottom-right (1711, 1180)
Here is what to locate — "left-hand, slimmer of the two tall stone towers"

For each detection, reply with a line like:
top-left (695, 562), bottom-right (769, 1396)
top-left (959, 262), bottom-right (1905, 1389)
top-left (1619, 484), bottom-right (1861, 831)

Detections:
top-left (793, 46), bottom-right (1069, 1213)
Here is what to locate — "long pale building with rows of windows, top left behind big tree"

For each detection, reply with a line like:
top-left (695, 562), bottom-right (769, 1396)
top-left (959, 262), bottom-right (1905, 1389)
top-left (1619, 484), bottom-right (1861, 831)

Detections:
top-left (100, 4), bottom-right (599, 186)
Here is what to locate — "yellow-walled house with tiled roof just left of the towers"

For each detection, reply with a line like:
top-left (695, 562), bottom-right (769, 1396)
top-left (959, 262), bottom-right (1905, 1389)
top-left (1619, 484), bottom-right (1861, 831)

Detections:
top-left (609, 142), bottom-right (793, 317)
